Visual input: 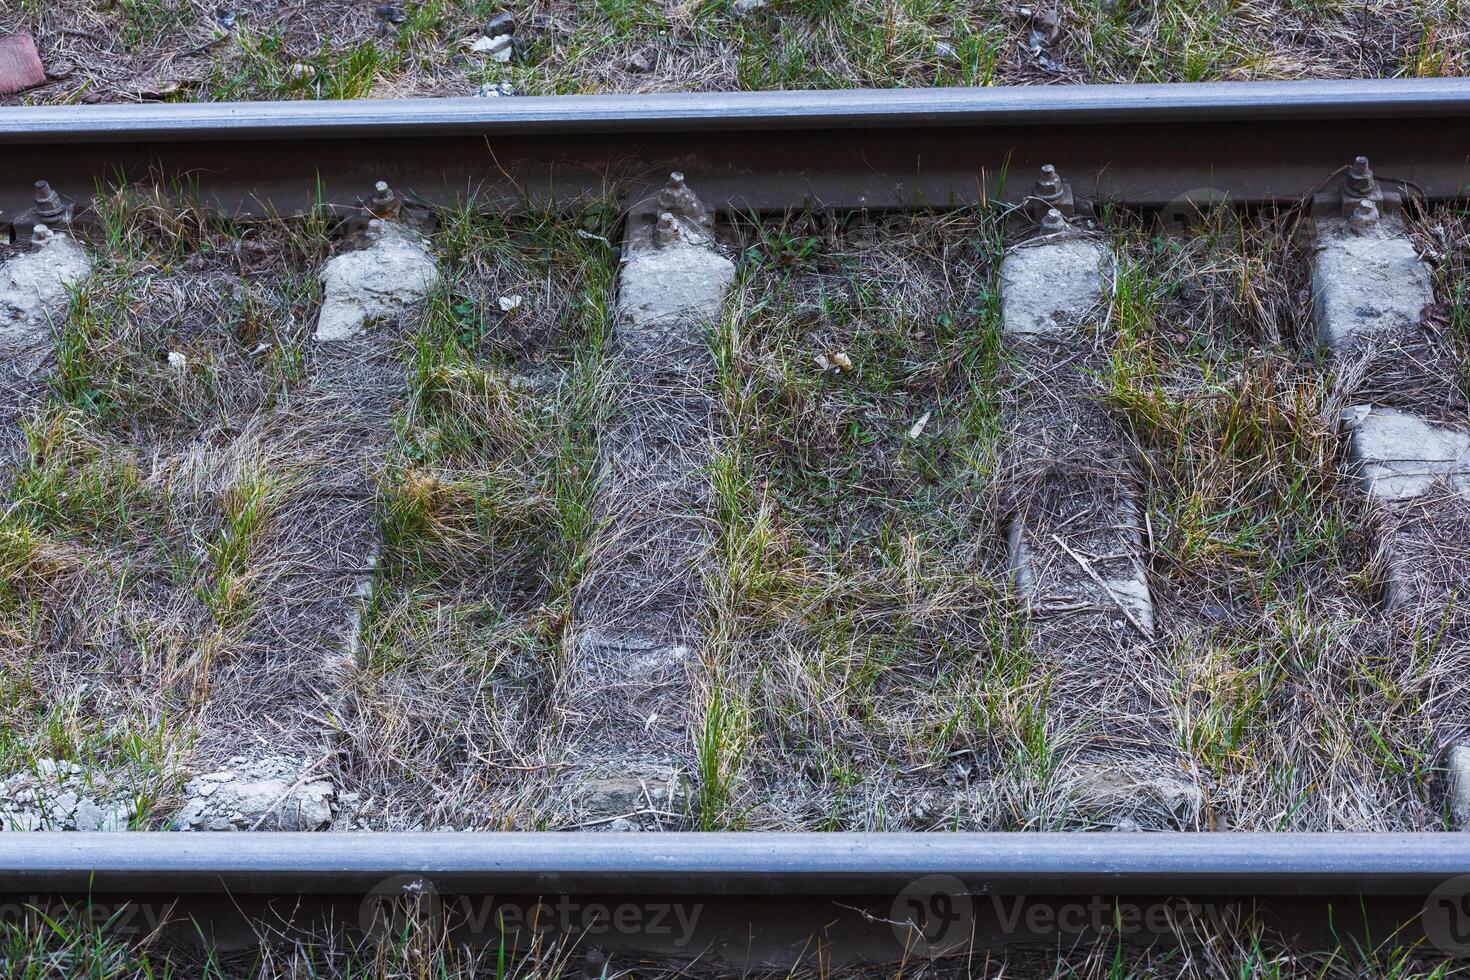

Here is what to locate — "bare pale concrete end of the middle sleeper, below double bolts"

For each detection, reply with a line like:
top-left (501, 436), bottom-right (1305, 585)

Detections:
top-left (617, 237), bottom-right (735, 328)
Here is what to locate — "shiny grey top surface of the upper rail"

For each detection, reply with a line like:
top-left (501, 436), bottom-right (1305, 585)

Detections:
top-left (0, 78), bottom-right (1470, 145)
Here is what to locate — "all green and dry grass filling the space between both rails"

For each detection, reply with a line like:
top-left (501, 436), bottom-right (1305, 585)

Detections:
top-left (0, 183), bottom-right (1470, 846)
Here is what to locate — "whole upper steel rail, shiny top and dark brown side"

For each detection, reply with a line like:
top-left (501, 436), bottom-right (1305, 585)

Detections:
top-left (0, 79), bottom-right (1470, 216)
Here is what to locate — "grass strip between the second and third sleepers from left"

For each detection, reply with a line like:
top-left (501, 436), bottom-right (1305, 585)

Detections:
top-left (330, 202), bottom-right (614, 829)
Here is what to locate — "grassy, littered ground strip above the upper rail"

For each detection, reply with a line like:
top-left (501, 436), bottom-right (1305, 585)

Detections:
top-left (0, 0), bottom-right (1470, 104)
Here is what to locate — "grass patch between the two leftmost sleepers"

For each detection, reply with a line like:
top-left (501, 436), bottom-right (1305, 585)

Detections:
top-left (0, 191), bottom-right (332, 821)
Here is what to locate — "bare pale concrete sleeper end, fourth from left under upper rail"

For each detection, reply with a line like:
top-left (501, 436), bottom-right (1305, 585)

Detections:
top-left (1001, 238), bottom-right (1110, 334)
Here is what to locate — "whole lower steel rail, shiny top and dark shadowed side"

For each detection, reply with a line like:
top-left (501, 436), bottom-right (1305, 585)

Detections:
top-left (0, 833), bottom-right (1470, 968)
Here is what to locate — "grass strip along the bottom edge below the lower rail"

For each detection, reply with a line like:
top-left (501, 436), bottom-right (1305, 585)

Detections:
top-left (0, 909), bottom-right (1461, 980)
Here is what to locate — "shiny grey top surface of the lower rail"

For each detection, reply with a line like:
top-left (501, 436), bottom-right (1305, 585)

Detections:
top-left (0, 832), bottom-right (1470, 895)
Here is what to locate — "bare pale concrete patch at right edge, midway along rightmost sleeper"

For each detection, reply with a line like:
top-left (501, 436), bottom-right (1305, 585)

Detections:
top-left (1342, 406), bottom-right (1470, 500)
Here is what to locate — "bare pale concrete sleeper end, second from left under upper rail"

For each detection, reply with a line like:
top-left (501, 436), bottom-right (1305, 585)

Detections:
top-left (316, 220), bottom-right (440, 342)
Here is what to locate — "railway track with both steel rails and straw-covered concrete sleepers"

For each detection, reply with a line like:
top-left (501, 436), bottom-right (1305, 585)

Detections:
top-left (0, 79), bottom-right (1470, 976)
